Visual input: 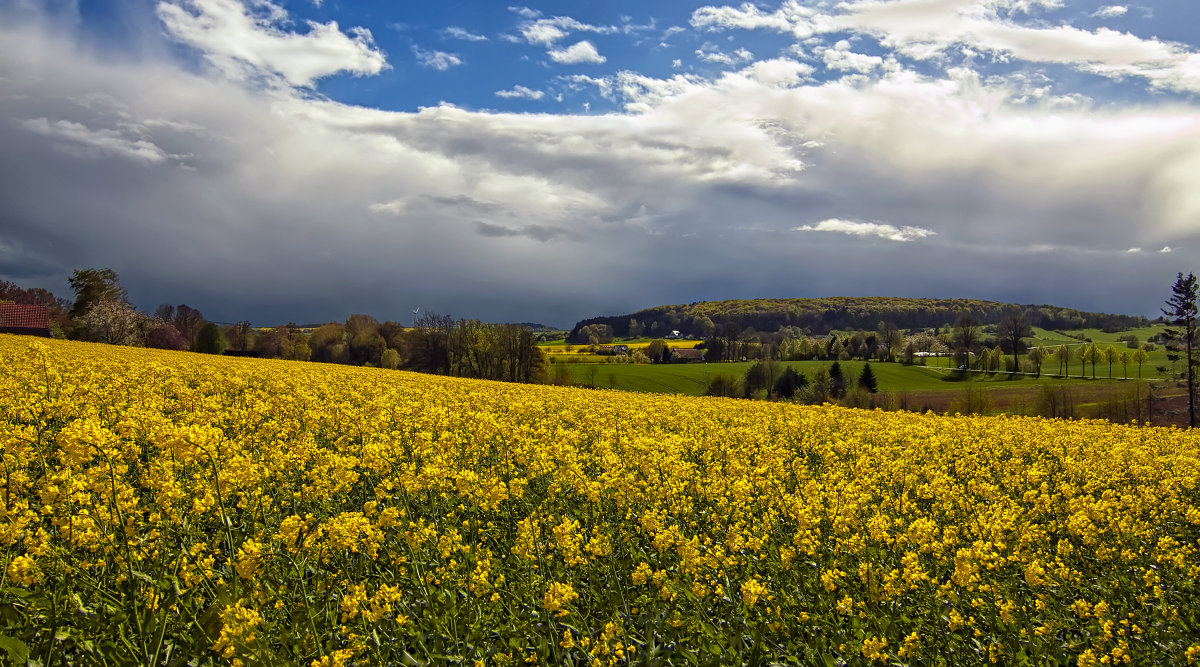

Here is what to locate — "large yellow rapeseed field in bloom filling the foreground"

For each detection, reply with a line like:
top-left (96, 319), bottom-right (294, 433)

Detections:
top-left (0, 336), bottom-right (1200, 666)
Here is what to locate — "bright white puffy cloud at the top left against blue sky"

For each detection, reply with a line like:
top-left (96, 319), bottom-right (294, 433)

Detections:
top-left (156, 0), bottom-right (386, 86)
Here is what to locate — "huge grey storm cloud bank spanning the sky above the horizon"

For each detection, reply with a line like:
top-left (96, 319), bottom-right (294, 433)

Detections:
top-left (0, 3), bottom-right (1200, 325)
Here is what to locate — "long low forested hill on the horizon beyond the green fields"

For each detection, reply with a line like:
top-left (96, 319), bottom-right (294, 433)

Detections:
top-left (571, 296), bottom-right (1148, 339)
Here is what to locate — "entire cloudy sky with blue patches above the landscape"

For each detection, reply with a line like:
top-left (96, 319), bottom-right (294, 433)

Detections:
top-left (0, 0), bottom-right (1200, 326)
